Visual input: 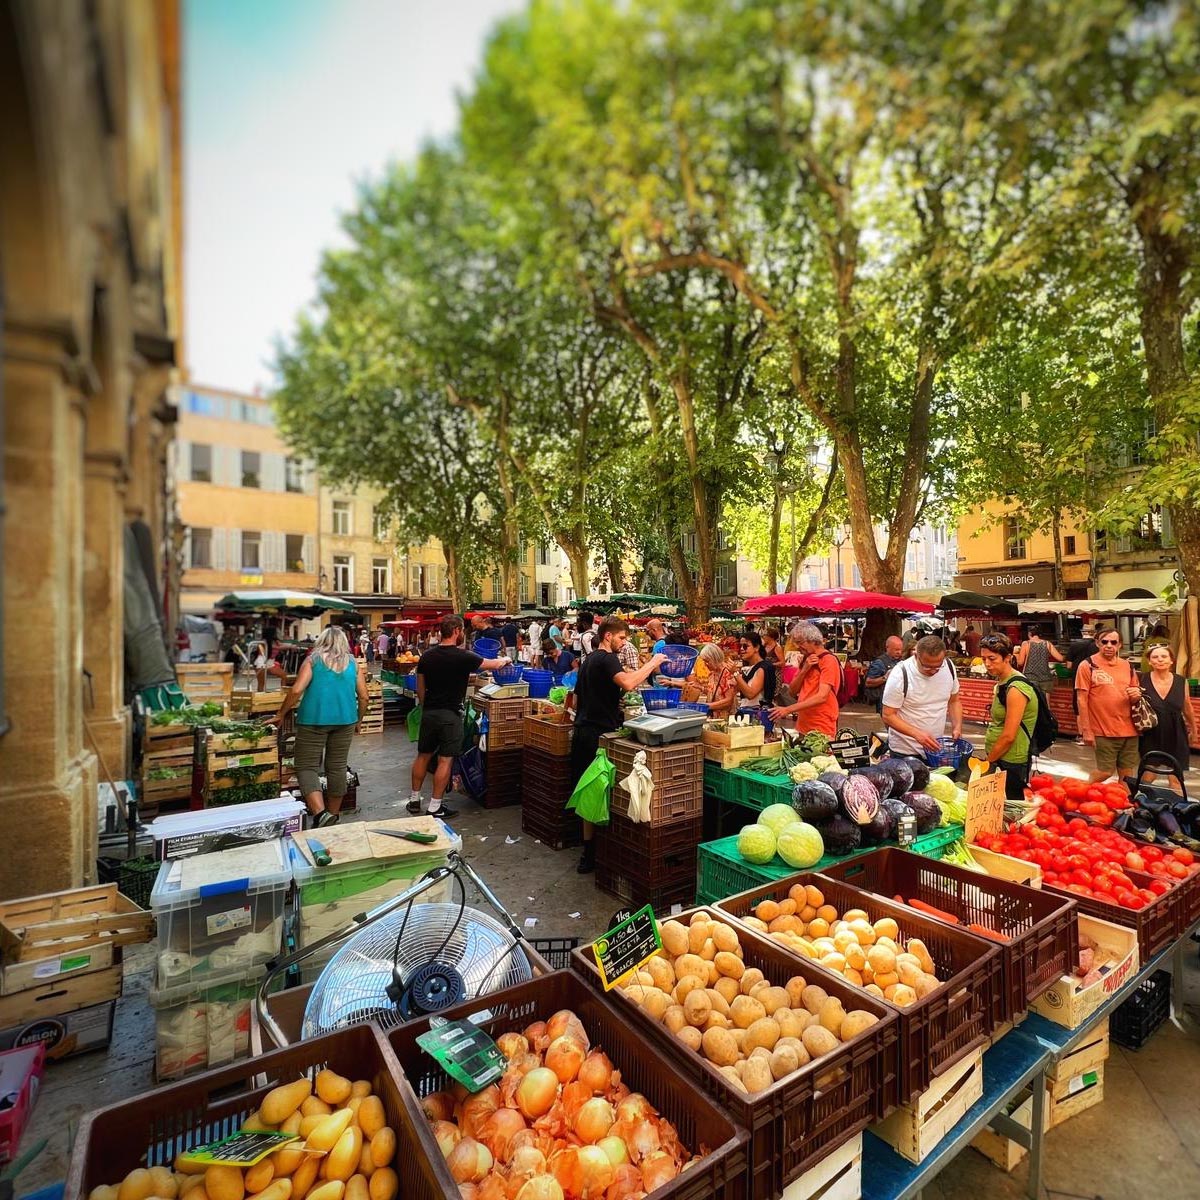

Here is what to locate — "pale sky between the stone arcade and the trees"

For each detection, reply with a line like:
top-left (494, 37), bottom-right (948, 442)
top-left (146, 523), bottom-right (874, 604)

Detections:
top-left (184, 0), bottom-right (523, 391)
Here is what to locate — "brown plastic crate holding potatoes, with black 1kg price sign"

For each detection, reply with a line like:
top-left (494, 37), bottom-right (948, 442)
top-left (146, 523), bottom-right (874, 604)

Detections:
top-left (571, 907), bottom-right (900, 1200)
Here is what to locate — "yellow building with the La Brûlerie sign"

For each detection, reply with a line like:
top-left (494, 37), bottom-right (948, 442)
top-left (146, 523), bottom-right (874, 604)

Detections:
top-left (954, 500), bottom-right (1092, 600)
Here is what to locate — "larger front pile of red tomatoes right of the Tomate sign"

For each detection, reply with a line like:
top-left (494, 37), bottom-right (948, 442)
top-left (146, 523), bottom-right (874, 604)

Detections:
top-left (976, 820), bottom-right (1200, 911)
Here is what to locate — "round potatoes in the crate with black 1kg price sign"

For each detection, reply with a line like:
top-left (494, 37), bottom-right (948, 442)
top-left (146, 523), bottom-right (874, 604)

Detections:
top-left (623, 912), bottom-right (878, 1093)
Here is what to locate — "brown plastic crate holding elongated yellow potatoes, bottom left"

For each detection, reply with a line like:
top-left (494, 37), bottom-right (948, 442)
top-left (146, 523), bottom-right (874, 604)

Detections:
top-left (64, 1025), bottom-right (436, 1200)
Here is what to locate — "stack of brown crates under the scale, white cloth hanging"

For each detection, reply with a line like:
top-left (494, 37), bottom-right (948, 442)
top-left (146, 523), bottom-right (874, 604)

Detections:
top-left (596, 733), bottom-right (704, 912)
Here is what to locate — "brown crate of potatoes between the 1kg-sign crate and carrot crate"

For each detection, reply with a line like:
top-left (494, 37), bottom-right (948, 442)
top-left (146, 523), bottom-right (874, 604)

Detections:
top-left (716, 872), bottom-right (1004, 1104)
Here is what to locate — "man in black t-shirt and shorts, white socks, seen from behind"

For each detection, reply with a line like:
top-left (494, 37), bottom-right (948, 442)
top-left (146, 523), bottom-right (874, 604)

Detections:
top-left (408, 617), bottom-right (510, 817)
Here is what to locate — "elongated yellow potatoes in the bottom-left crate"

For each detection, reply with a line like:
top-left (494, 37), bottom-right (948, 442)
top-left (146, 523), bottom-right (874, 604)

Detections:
top-left (88, 1070), bottom-right (400, 1200)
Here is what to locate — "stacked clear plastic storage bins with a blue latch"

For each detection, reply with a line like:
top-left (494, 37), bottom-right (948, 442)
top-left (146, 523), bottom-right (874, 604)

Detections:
top-left (150, 839), bottom-right (292, 1080)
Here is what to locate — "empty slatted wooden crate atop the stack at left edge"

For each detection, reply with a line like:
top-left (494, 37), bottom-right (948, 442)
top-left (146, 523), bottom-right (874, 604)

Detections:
top-left (0, 883), bottom-right (154, 962)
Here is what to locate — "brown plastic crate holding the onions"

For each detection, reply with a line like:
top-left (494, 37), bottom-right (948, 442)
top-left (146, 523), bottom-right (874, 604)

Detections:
top-left (391, 971), bottom-right (748, 1200)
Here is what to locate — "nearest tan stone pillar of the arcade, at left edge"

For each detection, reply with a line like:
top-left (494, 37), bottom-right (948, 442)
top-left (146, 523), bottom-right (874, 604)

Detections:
top-left (0, 322), bottom-right (96, 898)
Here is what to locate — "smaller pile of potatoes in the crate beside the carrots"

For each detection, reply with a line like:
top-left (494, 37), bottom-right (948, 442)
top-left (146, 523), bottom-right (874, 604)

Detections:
top-left (742, 883), bottom-right (941, 1008)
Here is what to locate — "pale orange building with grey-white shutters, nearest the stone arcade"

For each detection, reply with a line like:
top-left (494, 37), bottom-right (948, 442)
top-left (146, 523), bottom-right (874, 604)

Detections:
top-left (175, 384), bottom-right (318, 613)
